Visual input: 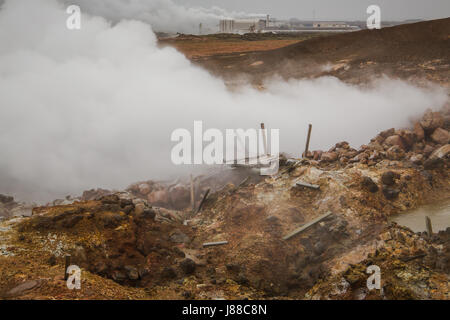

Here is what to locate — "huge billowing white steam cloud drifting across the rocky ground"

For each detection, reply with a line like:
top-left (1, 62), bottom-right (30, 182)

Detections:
top-left (0, 0), bottom-right (446, 199)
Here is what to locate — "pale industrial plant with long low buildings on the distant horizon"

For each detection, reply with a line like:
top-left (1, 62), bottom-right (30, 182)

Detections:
top-left (219, 15), bottom-right (361, 34)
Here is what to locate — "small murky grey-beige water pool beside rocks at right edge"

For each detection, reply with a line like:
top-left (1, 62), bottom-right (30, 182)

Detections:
top-left (389, 198), bottom-right (450, 232)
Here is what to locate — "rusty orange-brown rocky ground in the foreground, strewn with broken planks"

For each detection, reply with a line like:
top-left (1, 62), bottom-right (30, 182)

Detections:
top-left (0, 105), bottom-right (450, 299)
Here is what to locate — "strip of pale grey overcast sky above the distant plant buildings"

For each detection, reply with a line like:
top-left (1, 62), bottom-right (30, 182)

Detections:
top-left (174, 0), bottom-right (450, 20)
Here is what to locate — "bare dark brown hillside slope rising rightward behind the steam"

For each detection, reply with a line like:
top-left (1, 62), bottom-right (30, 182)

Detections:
top-left (196, 18), bottom-right (450, 85)
